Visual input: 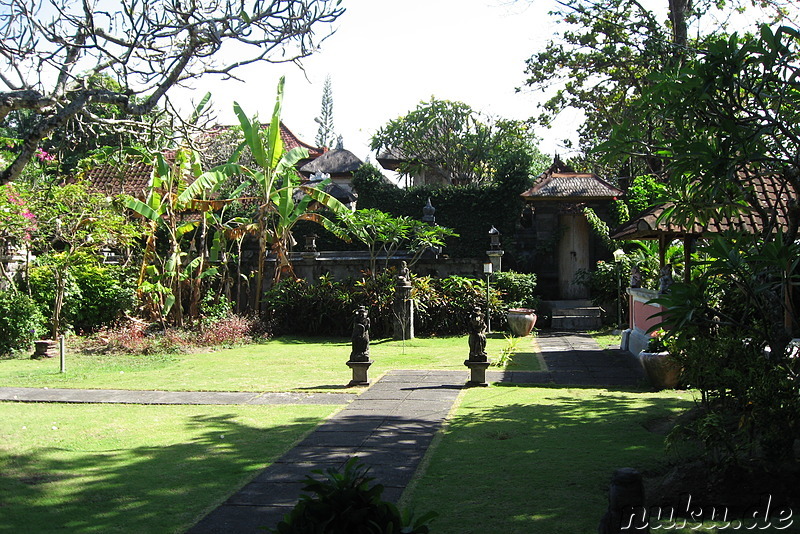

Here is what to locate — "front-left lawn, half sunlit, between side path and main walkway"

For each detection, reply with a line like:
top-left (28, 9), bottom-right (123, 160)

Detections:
top-left (0, 404), bottom-right (337, 533)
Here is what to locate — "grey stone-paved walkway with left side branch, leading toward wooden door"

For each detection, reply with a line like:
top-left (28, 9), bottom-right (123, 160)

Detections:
top-left (0, 332), bottom-right (643, 534)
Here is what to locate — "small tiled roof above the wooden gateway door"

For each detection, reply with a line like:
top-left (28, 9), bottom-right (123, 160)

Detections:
top-left (522, 175), bottom-right (623, 201)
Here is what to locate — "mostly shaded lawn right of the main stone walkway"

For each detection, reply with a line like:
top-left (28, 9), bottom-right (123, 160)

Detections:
top-left (409, 386), bottom-right (692, 534)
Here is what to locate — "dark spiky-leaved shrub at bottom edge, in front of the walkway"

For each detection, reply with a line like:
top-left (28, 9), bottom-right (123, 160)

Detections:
top-left (271, 458), bottom-right (436, 534)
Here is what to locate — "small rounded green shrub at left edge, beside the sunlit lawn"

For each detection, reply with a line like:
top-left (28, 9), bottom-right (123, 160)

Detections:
top-left (0, 291), bottom-right (45, 354)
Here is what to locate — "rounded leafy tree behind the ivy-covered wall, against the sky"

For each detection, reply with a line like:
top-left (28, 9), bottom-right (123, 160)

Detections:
top-left (371, 99), bottom-right (538, 189)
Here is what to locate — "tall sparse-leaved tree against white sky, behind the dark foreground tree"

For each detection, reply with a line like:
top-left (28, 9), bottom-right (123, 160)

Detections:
top-left (525, 0), bottom-right (791, 176)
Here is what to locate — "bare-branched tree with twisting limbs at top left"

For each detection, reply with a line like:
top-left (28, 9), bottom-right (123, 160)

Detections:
top-left (0, 0), bottom-right (344, 184)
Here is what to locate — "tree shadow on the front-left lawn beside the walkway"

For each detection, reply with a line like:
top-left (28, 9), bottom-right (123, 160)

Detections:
top-left (0, 415), bottom-right (318, 533)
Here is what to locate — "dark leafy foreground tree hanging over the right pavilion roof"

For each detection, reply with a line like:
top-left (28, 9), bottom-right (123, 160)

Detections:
top-left (597, 25), bottom-right (800, 244)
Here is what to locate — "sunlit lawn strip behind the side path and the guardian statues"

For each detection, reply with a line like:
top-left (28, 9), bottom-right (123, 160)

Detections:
top-left (0, 334), bottom-right (538, 392)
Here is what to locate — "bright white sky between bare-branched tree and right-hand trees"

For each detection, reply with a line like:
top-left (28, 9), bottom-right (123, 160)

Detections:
top-left (175, 0), bottom-right (580, 162)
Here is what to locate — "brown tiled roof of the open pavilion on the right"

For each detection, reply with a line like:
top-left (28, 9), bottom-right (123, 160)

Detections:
top-left (611, 171), bottom-right (789, 240)
